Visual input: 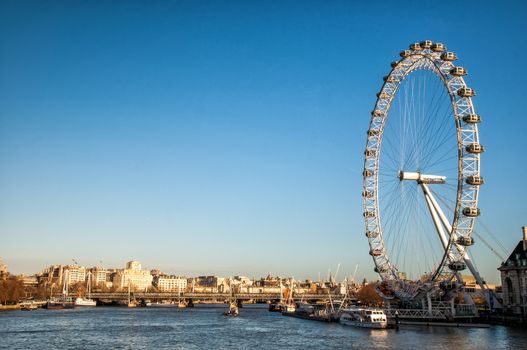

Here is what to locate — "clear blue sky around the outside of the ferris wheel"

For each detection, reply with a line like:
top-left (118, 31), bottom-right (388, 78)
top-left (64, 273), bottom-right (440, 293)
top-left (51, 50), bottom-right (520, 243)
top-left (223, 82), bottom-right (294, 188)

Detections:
top-left (0, 1), bottom-right (527, 281)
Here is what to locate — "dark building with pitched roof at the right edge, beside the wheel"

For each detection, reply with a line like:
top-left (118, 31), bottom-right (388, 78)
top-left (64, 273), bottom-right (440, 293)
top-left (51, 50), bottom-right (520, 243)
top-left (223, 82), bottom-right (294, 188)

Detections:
top-left (498, 226), bottom-right (527, 316)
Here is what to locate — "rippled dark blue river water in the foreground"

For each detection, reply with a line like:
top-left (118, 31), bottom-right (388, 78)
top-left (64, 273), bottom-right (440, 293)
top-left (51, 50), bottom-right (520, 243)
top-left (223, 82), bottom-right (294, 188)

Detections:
top-left (0, 305), bottom-right (527, 350)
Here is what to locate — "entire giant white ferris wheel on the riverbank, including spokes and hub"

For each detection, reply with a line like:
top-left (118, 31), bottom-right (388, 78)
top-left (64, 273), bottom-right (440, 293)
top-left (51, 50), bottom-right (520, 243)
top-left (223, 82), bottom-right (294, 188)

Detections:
top-left (362, 40), bottom-right (484, 300)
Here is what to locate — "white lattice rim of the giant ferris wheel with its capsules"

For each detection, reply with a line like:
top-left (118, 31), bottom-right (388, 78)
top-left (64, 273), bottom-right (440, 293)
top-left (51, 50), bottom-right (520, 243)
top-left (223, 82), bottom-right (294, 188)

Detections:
top-left (363, 41), bottom-right (481, 292)
